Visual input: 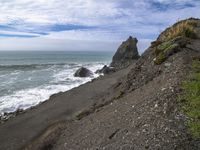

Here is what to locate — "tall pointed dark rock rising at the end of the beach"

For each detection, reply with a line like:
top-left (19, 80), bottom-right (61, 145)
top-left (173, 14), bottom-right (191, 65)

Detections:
top-left (110, 36), bottom-right (140, 69)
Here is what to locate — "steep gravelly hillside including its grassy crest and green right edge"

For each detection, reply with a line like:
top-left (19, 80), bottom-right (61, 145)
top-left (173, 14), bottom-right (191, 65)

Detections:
top-left (25, 18), bottom-right (200, 150)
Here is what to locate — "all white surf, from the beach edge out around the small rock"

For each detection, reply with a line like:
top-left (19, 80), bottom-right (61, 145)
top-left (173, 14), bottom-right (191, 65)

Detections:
top-left (0, 63), bottom-right (103, 115)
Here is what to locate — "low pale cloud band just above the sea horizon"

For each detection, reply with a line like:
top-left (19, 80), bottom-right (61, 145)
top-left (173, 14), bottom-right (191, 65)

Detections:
top-left (0, 37), bottom-right (120, 51)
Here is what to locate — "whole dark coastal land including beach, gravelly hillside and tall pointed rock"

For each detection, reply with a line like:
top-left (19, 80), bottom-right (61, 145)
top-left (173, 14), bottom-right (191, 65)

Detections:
top-left (0, 18), bottom-right (200, 150)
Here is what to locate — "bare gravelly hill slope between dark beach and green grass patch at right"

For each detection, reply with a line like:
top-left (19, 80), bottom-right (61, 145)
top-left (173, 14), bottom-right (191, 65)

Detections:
top-left (50, 19), bottom-right (200, 150)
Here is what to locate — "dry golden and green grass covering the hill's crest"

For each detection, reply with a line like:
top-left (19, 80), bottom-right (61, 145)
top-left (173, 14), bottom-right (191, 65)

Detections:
top-left (152, 19), bottom-right (198, 65)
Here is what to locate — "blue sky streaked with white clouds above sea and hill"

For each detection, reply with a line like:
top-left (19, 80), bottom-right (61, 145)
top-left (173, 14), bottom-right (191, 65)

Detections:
top-left (0, 0), bottom-right (200, 52)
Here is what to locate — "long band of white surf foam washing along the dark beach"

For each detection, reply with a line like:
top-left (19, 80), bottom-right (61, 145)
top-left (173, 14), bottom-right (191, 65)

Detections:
top-left (0, 78), bottom-right (91, 115)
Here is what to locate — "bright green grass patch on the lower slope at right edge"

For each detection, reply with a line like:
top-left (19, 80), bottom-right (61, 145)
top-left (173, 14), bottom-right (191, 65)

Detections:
top-left (180, 60), bottom-right (200, 138)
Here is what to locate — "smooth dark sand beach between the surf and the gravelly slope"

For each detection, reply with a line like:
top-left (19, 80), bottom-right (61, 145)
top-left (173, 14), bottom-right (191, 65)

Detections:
top-left (0, 68), bottom-right (130, 150)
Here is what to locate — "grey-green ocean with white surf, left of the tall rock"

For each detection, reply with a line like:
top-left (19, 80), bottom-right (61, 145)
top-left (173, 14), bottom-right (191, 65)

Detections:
top-left (0, 51), bottom-right (113, 115)
